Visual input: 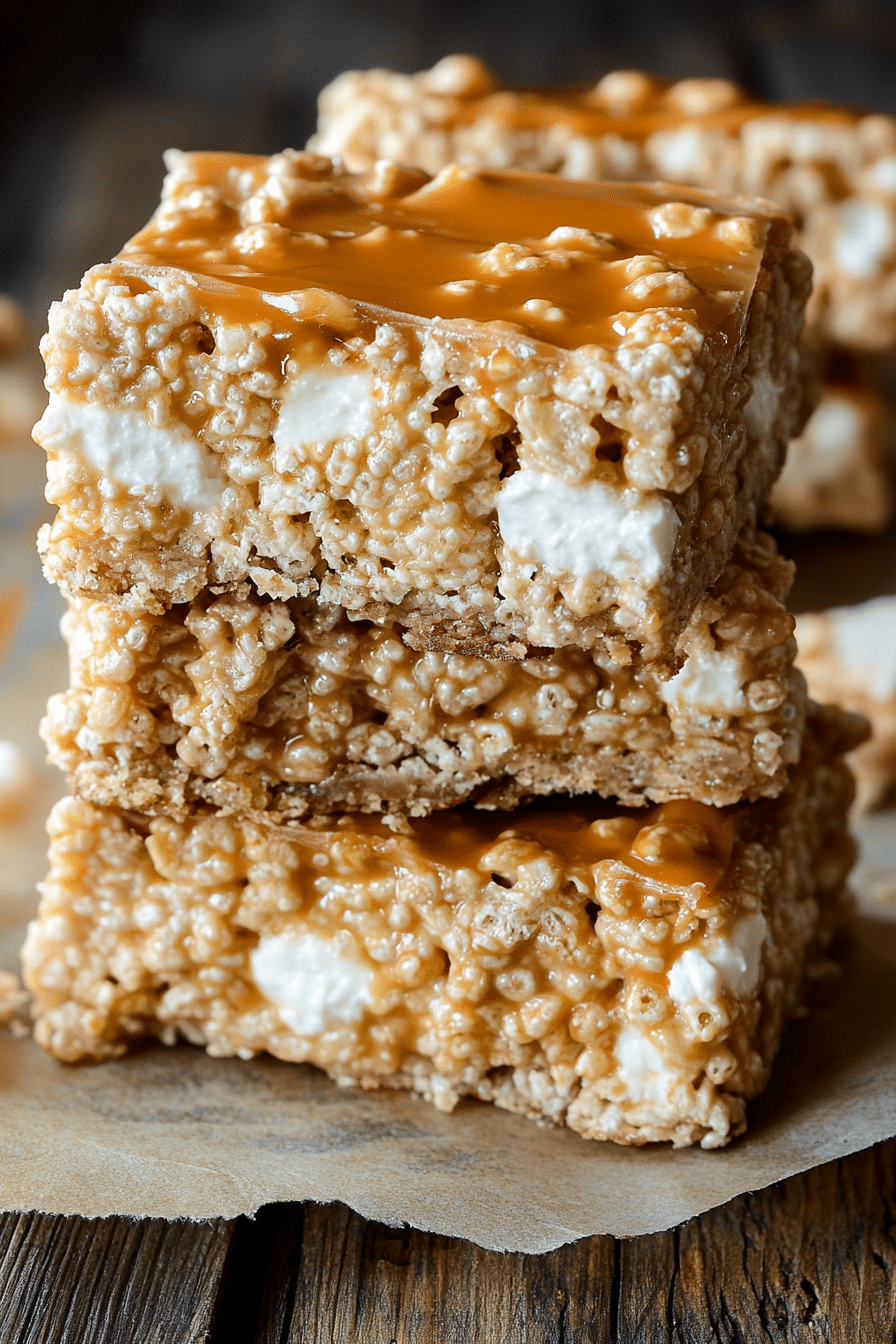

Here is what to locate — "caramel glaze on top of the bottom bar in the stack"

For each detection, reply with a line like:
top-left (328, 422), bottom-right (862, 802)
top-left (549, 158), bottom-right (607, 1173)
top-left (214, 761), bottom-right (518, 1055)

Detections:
top-left (302, 798), bottom-right (733, 891)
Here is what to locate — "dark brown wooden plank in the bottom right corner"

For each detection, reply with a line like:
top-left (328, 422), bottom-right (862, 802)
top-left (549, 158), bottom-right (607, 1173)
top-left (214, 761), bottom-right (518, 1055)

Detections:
top-left (618, 1142), bottom-right (896, 1344)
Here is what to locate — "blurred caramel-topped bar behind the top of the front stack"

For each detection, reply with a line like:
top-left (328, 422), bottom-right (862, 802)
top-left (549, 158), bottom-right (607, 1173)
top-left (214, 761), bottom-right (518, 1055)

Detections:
top-left (309, 56), bottom-right (896, 349)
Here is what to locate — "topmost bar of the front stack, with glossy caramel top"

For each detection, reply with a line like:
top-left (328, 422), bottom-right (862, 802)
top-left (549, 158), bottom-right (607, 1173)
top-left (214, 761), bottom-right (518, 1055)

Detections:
top-left (36, 152), bottom-right (809, 661)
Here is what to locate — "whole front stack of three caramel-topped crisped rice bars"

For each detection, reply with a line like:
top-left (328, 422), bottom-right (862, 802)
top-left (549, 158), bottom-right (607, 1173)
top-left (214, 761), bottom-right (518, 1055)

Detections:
top-left (24, 152), bottom-right (861, 1148)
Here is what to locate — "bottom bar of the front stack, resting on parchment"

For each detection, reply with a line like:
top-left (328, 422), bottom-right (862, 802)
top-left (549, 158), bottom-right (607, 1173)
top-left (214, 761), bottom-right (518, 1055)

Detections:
top-left (23, 708), bottom-right (861, 1148)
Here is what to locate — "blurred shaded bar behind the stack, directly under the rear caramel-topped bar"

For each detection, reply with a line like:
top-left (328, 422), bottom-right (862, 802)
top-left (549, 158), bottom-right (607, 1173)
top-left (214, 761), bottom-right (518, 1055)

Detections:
top-left (770, 376), bottom-right (893, 532)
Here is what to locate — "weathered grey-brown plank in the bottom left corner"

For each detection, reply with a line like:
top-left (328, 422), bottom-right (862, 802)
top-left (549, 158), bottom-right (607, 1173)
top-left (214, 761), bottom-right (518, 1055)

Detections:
top-left (0, 1214), bottom-right (232, 1344)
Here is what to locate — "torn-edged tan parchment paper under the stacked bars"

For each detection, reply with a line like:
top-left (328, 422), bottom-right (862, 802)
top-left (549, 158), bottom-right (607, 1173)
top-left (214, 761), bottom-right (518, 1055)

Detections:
top-left (0, 489), bottom-right (896, 1251)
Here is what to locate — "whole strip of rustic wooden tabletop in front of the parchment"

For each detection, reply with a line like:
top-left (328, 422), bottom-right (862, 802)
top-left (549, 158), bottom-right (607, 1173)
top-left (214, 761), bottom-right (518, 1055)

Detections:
top-left (0, 1142), bottom-right (896, 1344)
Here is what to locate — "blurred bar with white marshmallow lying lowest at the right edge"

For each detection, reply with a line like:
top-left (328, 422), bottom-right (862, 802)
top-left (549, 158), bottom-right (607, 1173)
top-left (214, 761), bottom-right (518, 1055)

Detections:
top-left (797, 597), bottom-right (896, 812)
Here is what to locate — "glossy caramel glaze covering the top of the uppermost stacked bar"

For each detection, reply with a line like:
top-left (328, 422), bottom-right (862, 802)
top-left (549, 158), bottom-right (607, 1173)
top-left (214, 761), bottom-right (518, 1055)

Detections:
top-left (113, 153), bottom-right (776, 348)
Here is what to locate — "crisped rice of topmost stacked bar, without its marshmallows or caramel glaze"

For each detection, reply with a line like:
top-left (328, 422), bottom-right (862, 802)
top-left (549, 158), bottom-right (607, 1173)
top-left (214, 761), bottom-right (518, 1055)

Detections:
top-left (36, 155), bottom-right (809, 669)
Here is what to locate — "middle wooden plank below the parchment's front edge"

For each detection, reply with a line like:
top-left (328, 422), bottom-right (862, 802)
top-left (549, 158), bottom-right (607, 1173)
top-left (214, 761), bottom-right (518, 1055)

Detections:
top-left (257, 1204), bottom-right (614, 1344)
